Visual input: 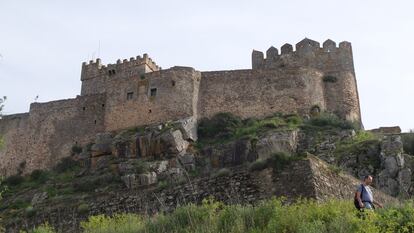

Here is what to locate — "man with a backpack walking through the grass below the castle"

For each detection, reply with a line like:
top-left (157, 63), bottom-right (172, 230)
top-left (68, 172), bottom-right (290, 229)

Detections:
top-left (355, 175), bottom-right (382, 209)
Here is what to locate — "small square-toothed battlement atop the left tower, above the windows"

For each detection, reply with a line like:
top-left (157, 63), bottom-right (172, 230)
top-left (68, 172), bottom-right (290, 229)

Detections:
top-left (81, 53), bottom-right (161, 81)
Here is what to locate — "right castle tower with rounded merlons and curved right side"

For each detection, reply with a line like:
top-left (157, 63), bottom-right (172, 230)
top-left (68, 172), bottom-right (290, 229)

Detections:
top-left (252, 38), bottom-right (361, 122)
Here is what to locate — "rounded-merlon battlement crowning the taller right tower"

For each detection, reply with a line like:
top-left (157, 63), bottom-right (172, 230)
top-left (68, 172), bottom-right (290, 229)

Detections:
top-left (252, 38), bottom-right (353, 70)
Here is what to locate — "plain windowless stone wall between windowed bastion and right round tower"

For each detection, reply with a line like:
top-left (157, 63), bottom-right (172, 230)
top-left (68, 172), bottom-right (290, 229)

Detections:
top-left (198, 68), bottom-right (325, 118)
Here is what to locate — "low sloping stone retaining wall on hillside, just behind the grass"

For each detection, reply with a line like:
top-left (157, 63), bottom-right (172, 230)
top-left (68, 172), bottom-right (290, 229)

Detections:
top-left (7, 156), bottom-right (397, 232)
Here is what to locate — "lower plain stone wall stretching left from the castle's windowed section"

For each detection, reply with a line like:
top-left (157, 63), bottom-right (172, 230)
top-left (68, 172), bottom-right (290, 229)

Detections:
top-left (0, 95), bottom-right (105, 175)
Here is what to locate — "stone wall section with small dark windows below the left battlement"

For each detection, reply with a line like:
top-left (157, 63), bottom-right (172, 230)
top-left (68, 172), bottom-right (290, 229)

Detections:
top-left (105, 67), bottom-right (201, 131)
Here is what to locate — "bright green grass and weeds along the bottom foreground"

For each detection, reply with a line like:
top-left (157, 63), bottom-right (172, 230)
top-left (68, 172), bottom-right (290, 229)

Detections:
top-left (25, 199), bottom-right (414, 233)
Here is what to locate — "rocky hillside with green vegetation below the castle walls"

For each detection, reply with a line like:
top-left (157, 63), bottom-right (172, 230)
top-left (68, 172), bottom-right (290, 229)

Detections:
top-left (0, 113), bottom-right (412, 232)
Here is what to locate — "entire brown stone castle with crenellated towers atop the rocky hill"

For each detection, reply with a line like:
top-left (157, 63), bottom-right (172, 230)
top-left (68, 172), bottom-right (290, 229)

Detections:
top-left (0, 38), bottom-right (361, 175)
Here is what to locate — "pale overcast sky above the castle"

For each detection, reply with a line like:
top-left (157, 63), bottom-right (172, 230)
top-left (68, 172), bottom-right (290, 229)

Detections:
top-left (0, 0), bottom-right (414, 131)
